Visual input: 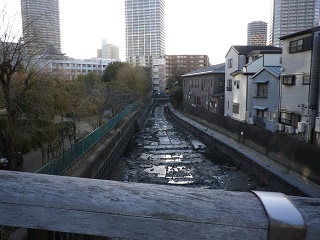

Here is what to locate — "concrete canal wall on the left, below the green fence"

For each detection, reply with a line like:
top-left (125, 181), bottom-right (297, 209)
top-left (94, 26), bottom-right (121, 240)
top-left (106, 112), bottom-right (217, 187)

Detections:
top-left (72, 99), bottom-right (153, 179)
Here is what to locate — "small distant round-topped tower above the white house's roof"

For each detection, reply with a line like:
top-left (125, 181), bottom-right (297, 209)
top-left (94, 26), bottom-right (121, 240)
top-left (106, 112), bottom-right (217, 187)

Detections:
top-left (247, 21), bottom-right (268, 46)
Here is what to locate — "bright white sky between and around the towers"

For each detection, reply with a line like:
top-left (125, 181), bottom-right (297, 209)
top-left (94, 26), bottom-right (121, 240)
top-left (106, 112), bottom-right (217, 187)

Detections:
top-left (0, 0), bottom-right (271, 64)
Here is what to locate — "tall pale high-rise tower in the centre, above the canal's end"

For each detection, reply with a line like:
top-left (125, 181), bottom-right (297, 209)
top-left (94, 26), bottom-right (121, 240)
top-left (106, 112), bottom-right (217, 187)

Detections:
top-left (125, 0), bottom-right (165, 66)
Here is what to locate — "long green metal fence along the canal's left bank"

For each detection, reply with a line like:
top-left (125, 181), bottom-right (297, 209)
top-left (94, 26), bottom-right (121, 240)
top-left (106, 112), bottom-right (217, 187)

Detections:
top-left (37, 101), bottom-right (140, 175)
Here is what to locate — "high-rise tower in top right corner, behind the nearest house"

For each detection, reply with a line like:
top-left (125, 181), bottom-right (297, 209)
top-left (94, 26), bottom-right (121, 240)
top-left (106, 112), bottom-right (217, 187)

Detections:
top-left (270, 0), bottom-right (320, 47)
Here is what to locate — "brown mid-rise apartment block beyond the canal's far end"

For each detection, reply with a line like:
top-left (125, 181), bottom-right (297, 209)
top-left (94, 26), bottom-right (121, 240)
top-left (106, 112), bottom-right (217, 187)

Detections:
top-left (165, 55), bottom-right (210, 78)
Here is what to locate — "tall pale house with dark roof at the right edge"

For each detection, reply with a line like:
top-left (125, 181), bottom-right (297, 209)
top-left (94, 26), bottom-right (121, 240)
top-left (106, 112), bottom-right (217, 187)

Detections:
top-left (279, 26), bottom-right (320, 145)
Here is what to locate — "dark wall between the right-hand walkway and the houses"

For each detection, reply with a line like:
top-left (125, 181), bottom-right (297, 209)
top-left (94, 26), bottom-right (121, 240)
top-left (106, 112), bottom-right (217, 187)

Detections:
top-left (174, 104), bottom-right (320, 191)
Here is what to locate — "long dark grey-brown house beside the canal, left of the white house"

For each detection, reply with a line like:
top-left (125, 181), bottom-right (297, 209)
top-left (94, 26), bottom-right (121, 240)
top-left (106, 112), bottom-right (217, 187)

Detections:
top-left (181, 63), bottom-right (225, 115)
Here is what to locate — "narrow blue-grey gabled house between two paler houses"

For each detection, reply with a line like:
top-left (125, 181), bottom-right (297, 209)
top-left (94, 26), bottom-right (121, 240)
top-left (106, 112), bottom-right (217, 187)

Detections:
top-left (251, 66), bottom-right (281, 132)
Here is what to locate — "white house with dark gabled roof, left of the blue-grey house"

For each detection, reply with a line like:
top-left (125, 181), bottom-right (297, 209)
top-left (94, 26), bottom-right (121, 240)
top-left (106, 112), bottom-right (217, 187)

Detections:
top-left (224, 46), bottom-right (282, 122)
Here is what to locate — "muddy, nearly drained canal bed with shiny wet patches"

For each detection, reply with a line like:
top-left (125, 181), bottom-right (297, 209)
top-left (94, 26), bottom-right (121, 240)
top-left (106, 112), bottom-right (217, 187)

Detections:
top-left (111, 106), bottom-right (273, 191)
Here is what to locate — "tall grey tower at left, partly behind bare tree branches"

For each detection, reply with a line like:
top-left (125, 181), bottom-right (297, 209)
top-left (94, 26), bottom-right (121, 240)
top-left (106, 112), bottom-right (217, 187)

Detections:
top-left (21, 0), bottom-right (61, 54)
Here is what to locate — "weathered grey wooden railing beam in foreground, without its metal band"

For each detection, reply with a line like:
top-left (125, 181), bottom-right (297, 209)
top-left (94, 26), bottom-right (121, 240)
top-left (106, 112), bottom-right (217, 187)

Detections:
top-left (0, 171), bottom-right (320, 240)
